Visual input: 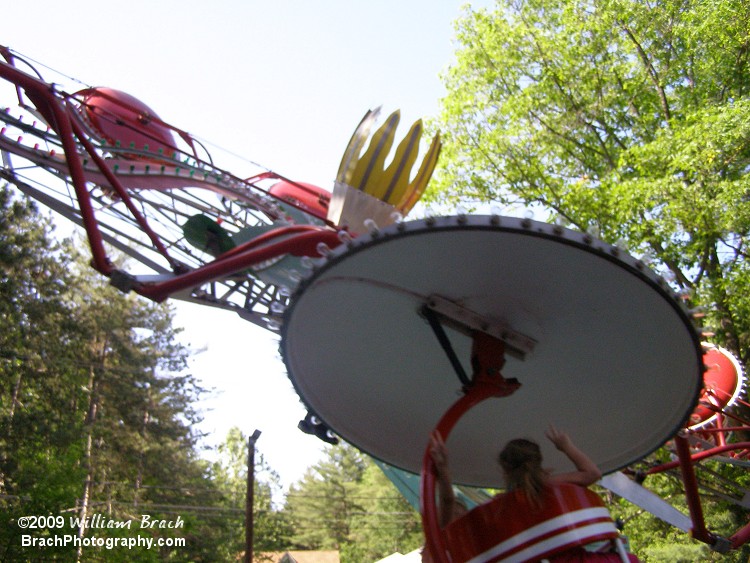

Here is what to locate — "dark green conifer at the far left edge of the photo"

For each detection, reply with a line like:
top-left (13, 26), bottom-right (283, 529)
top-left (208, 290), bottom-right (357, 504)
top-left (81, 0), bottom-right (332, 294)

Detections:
top-left (0, 187), bottom-right (90, 560)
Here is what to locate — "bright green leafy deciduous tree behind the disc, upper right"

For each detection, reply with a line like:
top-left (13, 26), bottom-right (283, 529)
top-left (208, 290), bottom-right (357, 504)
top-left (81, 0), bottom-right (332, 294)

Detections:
top-left (428, 0), bottom-right (750, 561)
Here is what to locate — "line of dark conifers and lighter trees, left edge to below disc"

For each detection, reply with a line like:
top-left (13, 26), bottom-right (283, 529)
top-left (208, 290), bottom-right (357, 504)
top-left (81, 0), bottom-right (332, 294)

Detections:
top-left (0, 189), bottom-right (421, 562)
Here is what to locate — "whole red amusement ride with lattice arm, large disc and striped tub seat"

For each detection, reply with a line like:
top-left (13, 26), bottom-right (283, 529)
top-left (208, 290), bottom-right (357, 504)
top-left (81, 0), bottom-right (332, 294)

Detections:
top-left (0, 47), bottom-right (750, 562)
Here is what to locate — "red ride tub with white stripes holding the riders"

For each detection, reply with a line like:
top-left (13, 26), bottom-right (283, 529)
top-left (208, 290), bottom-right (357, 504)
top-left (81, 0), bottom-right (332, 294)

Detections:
top-left (445, 484), bottom-right (628, 563)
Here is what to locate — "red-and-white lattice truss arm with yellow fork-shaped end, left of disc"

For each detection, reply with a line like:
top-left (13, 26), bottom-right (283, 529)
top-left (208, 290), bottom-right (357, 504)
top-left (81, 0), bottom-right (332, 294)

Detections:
top-left (0, 48), bottom-right (440, 331)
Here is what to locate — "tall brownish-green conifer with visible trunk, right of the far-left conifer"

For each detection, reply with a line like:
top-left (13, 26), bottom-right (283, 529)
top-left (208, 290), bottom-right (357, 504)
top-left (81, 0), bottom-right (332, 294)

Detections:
top-left (62, 259), bottom-right (212, 561)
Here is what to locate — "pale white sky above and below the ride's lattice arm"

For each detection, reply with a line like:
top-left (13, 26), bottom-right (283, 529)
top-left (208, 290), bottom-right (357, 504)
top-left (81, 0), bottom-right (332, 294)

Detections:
top-left (0, 0), bottom-right (491, 487)
